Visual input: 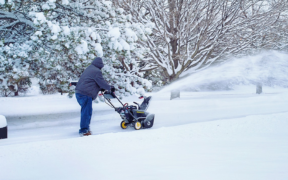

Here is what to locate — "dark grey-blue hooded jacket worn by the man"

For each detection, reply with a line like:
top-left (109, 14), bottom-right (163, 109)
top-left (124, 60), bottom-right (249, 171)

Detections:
top-left (75, 57), bottom-right (111, 100)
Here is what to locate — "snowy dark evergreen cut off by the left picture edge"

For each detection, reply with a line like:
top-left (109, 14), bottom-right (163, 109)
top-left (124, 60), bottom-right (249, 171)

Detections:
top-left (0, 1), bottom-right (34, 96)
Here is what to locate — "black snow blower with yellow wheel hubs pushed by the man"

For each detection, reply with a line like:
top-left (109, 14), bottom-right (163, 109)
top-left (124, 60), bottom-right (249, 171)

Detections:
top-left (100, 91), bottom-right (155, 130)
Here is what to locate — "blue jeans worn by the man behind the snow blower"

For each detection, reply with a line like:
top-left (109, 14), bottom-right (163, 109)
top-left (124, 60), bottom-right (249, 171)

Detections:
top-left (76, 93), bottom-right (92, 134)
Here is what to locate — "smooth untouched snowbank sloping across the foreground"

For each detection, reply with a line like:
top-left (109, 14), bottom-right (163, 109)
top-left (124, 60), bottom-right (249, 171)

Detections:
top-left (0, 113), bottom-right (288, 180)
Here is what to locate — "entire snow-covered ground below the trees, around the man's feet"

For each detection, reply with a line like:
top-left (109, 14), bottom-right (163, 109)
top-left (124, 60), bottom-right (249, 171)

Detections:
top-left (0, 86), bottom-right (288, 180)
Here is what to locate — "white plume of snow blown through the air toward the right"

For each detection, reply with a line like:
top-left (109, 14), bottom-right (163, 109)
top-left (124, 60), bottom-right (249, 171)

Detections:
top-left (162, 51), bottom-right (288, 92)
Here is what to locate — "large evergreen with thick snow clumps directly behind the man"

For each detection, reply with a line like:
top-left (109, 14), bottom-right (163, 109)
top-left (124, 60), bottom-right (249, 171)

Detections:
top-left (1, 0), bottom-right (151, 95)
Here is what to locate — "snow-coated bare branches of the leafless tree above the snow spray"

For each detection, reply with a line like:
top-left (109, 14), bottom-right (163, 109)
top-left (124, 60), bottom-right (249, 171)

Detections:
top-left (111, 0), bottom-right (287, 80)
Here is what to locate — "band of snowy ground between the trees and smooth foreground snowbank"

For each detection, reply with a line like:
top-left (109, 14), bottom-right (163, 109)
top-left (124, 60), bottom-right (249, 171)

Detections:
top-left (0, 91), bottom-right (288, 145)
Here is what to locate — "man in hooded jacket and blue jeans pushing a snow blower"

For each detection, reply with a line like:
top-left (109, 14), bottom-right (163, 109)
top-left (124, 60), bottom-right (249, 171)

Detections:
top-left (75, 57), bottom-right (115, 136)
